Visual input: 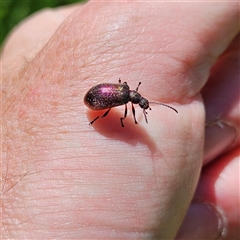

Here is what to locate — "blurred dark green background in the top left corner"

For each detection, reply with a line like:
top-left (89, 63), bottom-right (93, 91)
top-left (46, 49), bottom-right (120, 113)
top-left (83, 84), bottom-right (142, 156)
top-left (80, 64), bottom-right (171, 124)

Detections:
top-left (0, 0), bottom-right (86, 45)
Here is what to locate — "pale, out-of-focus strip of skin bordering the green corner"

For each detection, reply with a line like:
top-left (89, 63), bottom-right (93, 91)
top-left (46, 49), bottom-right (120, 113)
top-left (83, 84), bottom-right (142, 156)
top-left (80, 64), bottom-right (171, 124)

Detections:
top-left (1, 5), bottom-right (78, 70)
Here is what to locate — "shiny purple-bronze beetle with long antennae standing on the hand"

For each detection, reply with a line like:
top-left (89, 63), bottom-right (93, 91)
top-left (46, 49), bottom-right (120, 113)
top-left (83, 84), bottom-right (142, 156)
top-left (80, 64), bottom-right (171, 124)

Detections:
top-left (84, 78), bottom-right (178, 127)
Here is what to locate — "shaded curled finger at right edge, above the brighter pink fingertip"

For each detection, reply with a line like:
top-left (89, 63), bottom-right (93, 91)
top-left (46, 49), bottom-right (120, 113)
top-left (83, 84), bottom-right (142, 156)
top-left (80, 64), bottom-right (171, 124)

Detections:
top-left (202, 34), bottom-right (240, 164)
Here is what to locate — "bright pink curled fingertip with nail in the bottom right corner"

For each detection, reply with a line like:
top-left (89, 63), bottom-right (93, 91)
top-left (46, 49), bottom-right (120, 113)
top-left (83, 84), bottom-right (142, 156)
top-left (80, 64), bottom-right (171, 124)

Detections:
top-left (177, 148), bottom-right (240, 239)
